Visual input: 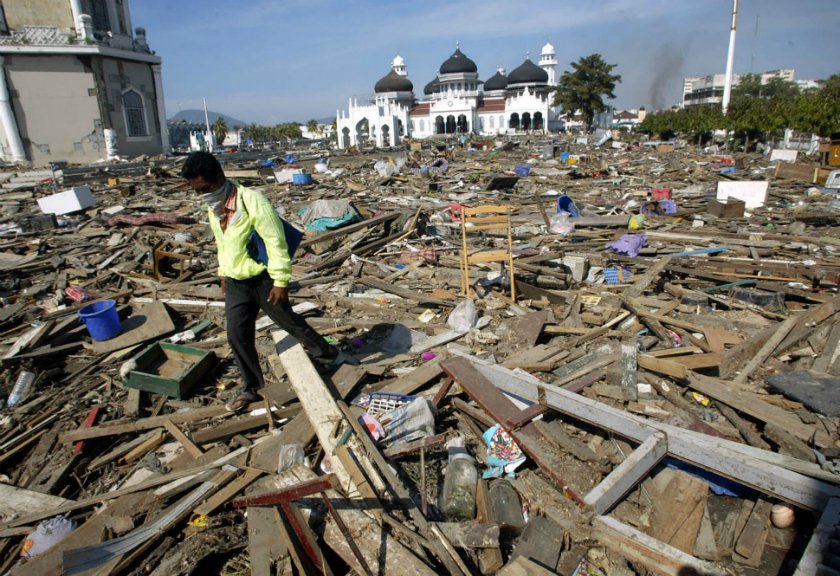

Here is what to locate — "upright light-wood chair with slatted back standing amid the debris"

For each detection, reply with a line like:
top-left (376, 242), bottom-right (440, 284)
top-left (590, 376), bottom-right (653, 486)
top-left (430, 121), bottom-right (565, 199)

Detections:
top-left (461, 204), bottom-right (516, 302)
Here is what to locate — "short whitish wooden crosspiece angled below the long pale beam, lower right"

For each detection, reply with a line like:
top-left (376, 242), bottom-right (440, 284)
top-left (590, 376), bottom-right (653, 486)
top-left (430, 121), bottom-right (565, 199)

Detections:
top-left (583, 432), bottom-right (668, 514)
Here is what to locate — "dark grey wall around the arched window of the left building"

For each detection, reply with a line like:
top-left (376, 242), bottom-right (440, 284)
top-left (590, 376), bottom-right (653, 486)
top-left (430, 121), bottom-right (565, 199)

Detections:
top-left (102, 58), bottom-right (163, 158)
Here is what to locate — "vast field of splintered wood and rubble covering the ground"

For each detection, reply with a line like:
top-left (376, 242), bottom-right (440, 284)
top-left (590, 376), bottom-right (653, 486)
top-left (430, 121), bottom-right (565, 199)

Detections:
top-left (0, 137), bottom-right (840, 576)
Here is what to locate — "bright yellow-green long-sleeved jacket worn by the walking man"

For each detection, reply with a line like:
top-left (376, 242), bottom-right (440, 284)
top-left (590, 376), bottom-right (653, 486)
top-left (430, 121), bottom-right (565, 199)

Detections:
top-left (207, 183), bottom-right (292, 288)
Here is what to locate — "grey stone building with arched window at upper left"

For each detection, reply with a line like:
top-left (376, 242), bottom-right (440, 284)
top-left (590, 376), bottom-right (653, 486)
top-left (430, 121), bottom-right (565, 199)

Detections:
top-left (0, 0), bottom-right (169, 165)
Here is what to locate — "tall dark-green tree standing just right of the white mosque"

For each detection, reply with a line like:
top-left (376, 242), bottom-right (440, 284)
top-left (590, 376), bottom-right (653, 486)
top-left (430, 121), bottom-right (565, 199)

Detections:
top-left (554, 54), bottom-right (621, 128)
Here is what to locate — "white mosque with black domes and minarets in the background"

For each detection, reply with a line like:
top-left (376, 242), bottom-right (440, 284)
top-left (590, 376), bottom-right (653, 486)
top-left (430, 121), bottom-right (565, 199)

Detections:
top-left (337, 43), bottom-right (557, 148)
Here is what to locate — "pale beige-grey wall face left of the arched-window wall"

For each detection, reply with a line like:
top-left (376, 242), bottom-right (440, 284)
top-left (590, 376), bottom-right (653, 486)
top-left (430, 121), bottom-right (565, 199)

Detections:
top-left (4, 53), bottom-right (105, 166)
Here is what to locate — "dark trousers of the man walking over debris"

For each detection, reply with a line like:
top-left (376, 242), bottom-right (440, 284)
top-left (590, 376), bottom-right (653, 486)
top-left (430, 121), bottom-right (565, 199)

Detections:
top-left (225, 273), bottom-right (336, 392)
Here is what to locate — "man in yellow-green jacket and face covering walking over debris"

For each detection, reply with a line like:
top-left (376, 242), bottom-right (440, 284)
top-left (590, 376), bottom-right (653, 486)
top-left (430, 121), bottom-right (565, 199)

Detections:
top-left (181, 152), bottom-right (345, 412)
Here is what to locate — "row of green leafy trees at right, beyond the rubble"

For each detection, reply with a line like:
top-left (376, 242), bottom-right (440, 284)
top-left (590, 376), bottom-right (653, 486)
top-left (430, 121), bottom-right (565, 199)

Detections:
top-left (638, 74), bottom-right (840, 150)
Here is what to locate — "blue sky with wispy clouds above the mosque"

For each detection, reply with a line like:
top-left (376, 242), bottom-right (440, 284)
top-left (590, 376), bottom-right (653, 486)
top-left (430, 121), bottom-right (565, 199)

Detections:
top-left (131, 0), bottom-right (840, 124)
